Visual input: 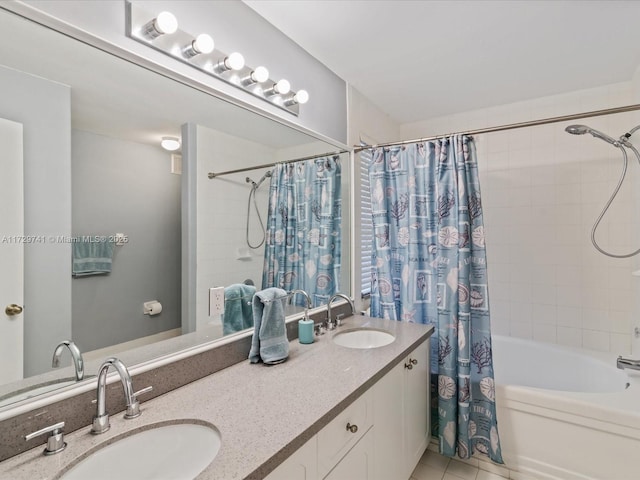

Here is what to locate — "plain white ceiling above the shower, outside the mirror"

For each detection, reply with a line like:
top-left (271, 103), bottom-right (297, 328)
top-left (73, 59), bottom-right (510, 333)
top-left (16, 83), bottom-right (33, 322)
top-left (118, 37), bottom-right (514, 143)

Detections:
top-left (243, 0), bottom-right (640, 124)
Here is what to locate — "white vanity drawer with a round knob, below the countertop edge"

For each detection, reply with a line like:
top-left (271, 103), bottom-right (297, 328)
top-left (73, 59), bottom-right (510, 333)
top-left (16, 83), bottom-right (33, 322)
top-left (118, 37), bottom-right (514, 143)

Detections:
top-left (318, 390), bottom-right (373, 478)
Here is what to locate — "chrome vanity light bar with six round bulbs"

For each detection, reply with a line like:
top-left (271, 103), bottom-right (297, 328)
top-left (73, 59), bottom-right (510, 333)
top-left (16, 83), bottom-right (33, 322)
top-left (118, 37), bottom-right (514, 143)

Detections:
top-left (126, 2), bottom-right (309, 116)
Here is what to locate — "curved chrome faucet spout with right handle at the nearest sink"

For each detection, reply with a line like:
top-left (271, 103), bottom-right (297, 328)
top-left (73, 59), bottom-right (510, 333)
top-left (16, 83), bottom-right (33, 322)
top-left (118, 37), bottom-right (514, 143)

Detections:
top-left (91, 357), bottom-right (152, 435)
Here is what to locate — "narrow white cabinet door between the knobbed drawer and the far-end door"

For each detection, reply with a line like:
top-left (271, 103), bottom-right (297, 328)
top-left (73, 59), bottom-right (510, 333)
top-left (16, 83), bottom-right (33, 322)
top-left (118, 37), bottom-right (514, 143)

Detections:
top-left (372, 361), bottom-right (400, 480)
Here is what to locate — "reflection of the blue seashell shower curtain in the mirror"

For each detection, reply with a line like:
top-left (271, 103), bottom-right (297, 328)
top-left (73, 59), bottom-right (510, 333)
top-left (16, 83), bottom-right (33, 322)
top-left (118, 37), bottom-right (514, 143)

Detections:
top-left (262, 155), bottom-right (342, 307)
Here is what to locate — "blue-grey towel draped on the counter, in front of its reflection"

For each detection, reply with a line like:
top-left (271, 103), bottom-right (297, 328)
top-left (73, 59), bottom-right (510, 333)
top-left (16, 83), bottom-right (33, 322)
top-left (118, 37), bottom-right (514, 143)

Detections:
top-left (249, 288), bottom-right (289, 364)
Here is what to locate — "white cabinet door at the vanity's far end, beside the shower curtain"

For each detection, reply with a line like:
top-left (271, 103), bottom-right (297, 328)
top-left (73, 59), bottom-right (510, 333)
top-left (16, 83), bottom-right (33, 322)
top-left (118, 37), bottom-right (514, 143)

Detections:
top-left (403, 340), bottom-right (431, 478)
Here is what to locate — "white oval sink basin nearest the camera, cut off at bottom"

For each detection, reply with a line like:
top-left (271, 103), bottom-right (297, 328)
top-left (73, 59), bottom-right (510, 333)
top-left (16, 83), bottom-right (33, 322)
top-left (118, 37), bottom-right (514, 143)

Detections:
top-left (60, 422), bottom-right (220, 480)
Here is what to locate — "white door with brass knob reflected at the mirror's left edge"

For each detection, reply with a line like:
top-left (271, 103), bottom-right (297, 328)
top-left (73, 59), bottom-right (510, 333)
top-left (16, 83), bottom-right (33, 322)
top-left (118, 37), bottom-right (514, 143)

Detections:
top-left (0, 118), bottom-right (23, 384)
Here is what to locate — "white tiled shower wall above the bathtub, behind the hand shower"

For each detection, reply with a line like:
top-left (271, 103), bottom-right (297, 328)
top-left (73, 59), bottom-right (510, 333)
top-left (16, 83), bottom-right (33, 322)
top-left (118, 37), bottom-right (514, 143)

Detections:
top-left (401, 82), bottom-right (640, 354)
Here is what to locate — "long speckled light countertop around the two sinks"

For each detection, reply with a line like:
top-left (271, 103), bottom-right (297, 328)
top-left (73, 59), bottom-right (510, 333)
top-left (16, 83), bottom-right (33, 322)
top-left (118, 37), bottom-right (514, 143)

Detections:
top-left (0, 316), bottom-right (433, 480)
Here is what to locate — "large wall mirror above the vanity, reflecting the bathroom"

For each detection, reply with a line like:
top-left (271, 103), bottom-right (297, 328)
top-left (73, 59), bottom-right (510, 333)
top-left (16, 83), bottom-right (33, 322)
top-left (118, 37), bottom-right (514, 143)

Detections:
top-left (0, 10), bottom-right (349, 409)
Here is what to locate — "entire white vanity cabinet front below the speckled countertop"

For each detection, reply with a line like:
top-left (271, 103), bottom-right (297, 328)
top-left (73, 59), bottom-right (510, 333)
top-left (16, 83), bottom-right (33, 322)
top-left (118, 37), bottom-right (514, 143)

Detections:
top-left (266, 339), bottom-right (430, 480)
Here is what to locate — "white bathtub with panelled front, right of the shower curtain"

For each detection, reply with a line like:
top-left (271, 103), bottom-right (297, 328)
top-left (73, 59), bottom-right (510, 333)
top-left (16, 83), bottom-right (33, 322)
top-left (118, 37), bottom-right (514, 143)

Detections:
top-left (492, 335), bottom-right (640, 480)
